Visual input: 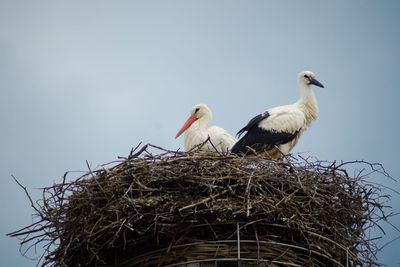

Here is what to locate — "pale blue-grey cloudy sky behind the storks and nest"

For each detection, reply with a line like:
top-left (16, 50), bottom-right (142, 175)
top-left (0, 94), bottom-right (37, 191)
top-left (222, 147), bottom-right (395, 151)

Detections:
top-left (0, 0), bottom-right (400, 266)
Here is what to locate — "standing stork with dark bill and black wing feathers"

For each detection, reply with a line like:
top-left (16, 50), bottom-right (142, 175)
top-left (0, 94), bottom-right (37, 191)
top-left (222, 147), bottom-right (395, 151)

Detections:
top-left (231, 71), bottom-right (324, 159)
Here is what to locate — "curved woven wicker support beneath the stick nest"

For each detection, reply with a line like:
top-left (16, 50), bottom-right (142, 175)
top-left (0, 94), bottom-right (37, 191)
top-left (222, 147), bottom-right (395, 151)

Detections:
top-left (117, 221), bottom-right (355, 266)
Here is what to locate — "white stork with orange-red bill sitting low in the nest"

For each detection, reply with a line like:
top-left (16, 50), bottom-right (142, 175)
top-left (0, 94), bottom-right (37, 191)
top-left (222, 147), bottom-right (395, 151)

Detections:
top-left (175, 104), bottom-right (237, 153)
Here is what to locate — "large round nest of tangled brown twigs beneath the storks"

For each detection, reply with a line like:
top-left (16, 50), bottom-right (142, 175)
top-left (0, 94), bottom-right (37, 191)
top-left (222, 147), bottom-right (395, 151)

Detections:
top-left (10, 145), bottom-right (390, 266)
